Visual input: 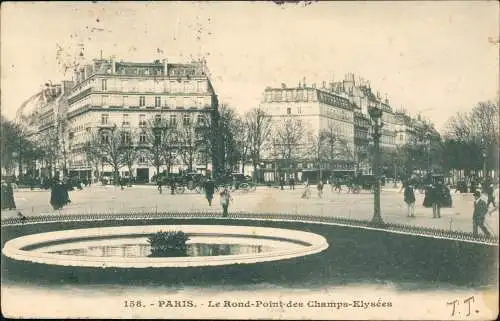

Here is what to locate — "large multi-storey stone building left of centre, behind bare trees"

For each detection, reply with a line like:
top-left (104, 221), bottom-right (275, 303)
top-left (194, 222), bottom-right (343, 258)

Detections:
top-left (67, 59), bottom-right (218, 181)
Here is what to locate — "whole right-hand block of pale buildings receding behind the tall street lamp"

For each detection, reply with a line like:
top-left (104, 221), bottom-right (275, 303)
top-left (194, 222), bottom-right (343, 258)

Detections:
top-left (260, 73), bottom-right (439, 180)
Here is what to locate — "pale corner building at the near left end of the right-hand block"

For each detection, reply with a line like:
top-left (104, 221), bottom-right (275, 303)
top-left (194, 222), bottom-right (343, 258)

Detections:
top-left (260, 83), bottom-right (354, 180)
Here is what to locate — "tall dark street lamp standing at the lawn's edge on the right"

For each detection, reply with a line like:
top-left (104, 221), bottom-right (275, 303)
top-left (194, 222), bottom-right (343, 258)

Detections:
top-left (368, 107), bottom-right (384, 226)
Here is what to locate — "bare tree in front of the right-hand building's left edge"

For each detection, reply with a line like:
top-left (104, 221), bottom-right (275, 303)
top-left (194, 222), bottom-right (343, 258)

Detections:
top-left (244, 108), bottom-right (272, 179)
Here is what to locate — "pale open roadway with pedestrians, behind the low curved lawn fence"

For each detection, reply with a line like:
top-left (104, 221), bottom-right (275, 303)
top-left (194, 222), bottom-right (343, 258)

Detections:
top-left (1, 185), bottom-right (498, 235)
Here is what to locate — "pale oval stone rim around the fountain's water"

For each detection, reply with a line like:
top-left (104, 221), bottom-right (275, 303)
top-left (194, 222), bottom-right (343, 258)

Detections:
top-left (2, 224), bottom-right (328, 268)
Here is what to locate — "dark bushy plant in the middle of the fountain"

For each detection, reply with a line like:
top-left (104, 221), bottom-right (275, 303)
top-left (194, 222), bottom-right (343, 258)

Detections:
top-left (148, 231), bottom-right (189, 257)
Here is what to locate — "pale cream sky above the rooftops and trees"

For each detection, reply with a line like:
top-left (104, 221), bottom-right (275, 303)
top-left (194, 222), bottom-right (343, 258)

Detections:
top-left (1, 1), bottom-right (499, 130)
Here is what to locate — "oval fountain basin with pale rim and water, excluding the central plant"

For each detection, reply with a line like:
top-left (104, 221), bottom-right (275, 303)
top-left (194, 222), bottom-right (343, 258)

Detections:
top-left (2, 225), bottom-right (328, 268)
